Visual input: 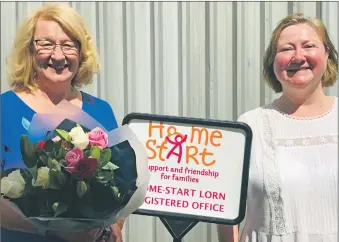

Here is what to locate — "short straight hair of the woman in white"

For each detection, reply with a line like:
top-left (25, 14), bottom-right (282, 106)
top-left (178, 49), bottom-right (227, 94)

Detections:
top-left (263, 13), bottom-right (338, 93)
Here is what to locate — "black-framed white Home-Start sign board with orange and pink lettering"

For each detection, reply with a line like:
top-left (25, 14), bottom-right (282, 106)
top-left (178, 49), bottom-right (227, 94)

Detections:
top-left (123, 113), bottom-right (252, 224)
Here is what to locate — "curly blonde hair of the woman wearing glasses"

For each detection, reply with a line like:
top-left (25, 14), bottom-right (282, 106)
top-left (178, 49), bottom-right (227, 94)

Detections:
top-left (7, 3), bottom-right (100, 90)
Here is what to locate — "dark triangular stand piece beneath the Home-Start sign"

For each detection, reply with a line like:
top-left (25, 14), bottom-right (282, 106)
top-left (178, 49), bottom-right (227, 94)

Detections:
top-left (160, 217), bottom-right (199, 242)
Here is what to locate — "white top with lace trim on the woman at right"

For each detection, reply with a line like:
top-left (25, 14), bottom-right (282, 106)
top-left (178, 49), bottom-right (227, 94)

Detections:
top-left (239, 97), bottom-right (338, 242)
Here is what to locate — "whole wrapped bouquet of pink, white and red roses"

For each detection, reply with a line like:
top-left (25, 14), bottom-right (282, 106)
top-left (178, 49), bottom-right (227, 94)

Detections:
top-left (1, 101), bottom-right (149, 232)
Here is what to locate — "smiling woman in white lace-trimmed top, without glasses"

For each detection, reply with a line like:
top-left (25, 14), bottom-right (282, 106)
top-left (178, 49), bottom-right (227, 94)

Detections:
top-left (218, 14), bottom-right (338, 242)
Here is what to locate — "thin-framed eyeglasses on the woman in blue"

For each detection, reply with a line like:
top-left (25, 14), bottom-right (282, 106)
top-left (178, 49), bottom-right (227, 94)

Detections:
top-left (33, 40), bottom-right (79, 55)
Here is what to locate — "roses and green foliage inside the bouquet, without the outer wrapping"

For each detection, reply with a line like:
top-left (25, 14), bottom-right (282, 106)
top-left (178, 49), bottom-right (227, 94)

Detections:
top-left (1, 125), bottom-right (126, 218)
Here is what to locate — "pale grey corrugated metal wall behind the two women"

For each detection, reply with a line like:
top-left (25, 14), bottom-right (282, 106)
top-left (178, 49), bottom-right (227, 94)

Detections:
top-left (1, 2), bottom-right (339, 242)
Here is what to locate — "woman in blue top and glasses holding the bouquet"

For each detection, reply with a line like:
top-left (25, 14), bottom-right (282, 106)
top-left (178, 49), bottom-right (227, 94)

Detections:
top-left (0, 4), bottom-right (122, 242)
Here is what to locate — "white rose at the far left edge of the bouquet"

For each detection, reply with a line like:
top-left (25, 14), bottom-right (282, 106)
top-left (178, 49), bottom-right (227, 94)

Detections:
top-left (1, 170), bottom-right (25, 198)
